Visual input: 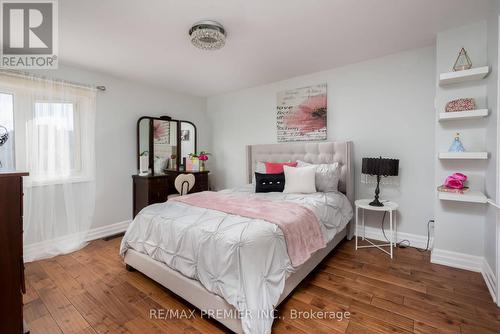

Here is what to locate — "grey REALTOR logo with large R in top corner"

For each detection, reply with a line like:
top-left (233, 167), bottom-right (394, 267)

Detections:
top-left (0, 0), bottom-right (57, 69)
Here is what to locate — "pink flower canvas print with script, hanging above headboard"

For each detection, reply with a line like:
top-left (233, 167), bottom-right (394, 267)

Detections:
top-left (277, 84), bottom-right (327, 142)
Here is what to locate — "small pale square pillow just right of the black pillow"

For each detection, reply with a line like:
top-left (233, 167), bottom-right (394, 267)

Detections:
top-left (283, 166), bottom-right (316, 194)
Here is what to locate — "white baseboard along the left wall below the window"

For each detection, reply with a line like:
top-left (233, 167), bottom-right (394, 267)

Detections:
top-left (23, 220), bottom-right (131, 262)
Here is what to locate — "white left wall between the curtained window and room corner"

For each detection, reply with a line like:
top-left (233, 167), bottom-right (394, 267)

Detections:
top-left (28, 66), bottom-right (210, 228)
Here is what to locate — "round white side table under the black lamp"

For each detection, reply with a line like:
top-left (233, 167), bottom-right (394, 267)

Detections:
top-left (354, 199), bottom-right (399, 259)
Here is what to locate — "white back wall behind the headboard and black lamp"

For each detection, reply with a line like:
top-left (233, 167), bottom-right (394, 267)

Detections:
top-left (207, 47), bottom-right (435, 235)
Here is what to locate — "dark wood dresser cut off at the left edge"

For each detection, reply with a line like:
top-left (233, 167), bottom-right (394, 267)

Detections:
top-left (0, 172), bottom-right (28, 334)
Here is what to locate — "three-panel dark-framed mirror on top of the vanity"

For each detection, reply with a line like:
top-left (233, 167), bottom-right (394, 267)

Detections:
top-left (137, 116), bottom-right (197, 175)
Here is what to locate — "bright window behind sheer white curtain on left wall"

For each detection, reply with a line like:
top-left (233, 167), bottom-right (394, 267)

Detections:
top-left (0, 73), bottom-right (95, 187)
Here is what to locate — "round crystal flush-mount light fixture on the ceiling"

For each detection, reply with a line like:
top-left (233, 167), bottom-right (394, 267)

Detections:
top-left (189, 21), bottom-right (226, 50)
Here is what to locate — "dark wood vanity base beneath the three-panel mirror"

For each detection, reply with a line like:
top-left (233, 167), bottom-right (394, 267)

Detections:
top-left (132, 170), bottom-right (209, 217)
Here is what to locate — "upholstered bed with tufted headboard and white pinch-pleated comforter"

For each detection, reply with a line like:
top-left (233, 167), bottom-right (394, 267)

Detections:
top-left (120, 142), bottom-right (354, 333)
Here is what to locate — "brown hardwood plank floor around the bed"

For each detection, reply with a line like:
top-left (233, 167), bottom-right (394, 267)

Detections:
top-left (24, 238), bottom-right (500, 334)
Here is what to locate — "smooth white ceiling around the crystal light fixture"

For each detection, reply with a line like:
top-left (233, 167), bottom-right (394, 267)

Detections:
top-left (59, 0), bottom-right (490, 96)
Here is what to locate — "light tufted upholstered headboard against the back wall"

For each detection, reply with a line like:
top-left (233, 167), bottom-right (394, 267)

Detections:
top-left (247, 141), bottom-right (354, 202)
